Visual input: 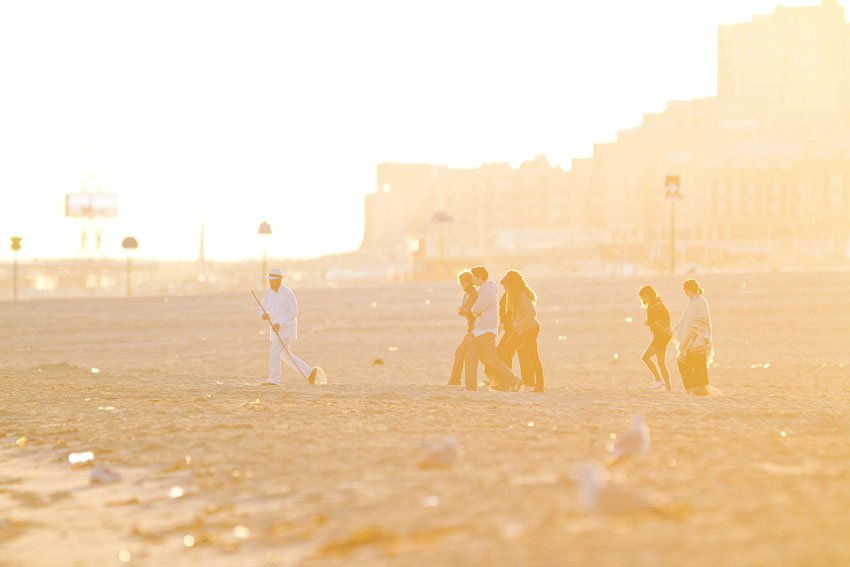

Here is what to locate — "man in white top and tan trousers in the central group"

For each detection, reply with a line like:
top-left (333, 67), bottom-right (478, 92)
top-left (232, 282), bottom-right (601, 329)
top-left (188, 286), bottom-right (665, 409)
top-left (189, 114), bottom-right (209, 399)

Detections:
top-left (466, 266), bottom-right (522, 392)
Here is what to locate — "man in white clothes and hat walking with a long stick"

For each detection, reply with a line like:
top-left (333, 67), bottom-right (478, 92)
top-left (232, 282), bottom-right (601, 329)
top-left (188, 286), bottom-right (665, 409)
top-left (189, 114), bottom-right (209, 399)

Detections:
top-left (258, 268), bottom-right (319, 384)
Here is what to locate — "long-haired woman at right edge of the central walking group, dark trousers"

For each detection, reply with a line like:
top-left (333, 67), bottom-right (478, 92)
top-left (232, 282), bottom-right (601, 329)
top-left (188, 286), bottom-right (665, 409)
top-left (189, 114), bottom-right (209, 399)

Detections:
top-left (502, 270), bottom-right (543, 392)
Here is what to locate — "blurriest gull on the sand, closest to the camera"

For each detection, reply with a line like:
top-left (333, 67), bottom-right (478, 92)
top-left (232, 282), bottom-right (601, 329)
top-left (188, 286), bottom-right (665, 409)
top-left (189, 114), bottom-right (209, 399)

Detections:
top-left (576, 462), bottom-right (678, 516)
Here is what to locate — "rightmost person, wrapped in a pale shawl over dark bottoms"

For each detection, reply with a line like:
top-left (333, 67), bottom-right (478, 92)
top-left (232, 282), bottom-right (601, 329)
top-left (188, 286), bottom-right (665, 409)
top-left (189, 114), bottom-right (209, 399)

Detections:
top-left (676, 279), bottom-right (714, 396)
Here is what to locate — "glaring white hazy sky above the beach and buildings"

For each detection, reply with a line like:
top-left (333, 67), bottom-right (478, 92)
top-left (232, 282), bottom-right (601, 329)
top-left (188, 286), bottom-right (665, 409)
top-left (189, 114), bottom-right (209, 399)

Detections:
top-left (0, 0), bottom-right (850, 260)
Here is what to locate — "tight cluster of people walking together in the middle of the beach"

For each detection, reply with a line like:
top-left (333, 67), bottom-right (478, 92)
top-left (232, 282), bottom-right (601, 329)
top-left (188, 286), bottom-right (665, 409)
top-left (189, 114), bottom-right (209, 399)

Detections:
top-left (449, 266), bottom-right (543, 392)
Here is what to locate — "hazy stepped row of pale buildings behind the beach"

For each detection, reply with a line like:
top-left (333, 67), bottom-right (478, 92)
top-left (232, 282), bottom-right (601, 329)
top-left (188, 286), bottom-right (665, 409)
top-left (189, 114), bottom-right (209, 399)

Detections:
top-left (363, 0), bottom-right (850, 269)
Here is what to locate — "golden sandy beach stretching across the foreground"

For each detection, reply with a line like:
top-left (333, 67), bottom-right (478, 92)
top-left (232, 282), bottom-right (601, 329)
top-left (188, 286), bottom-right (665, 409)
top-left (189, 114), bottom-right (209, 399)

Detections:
top-left (0, 273), bottom-right (850, 566)
